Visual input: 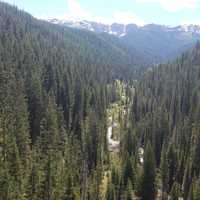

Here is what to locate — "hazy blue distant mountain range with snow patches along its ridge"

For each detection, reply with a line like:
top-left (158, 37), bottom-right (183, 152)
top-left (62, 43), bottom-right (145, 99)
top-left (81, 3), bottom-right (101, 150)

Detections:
top-left (48, 19), bottom-right (200, 64)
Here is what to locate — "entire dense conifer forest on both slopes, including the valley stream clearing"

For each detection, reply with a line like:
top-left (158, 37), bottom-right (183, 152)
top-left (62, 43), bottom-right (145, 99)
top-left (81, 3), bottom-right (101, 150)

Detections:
top-left (0, 2), bottom-right (200, 200)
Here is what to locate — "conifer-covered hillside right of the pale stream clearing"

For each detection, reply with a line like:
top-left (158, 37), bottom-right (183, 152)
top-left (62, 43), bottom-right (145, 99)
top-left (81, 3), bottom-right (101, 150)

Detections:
top-left (126, 43), bottom-right (200, 200)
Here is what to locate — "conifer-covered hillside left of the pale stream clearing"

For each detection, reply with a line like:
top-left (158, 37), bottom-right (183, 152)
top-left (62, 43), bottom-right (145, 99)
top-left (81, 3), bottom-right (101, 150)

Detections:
top-left (0, 3), bottom-right (132, 200)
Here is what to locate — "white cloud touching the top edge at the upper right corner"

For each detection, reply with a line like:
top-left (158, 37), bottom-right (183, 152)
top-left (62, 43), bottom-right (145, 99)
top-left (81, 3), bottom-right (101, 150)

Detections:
top-left (137, 0), bottom-right (200, 12)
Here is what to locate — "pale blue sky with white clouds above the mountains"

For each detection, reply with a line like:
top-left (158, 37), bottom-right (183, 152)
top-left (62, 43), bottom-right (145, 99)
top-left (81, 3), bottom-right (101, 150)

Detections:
top-left (3, 0), bottom-right (200, 26)
